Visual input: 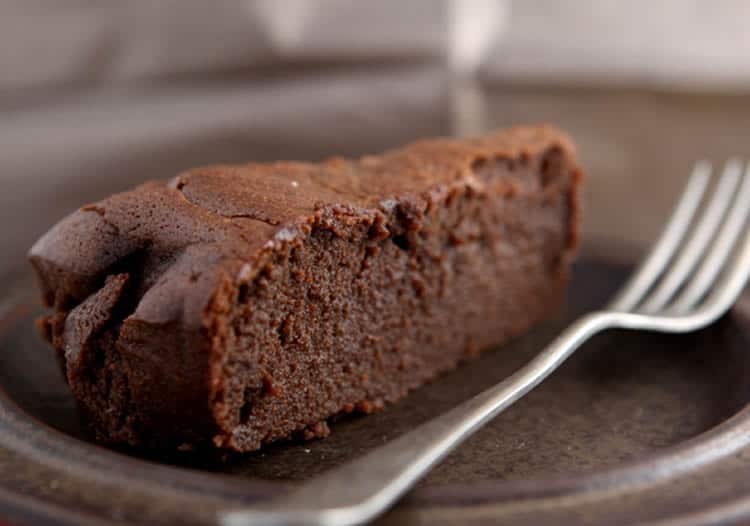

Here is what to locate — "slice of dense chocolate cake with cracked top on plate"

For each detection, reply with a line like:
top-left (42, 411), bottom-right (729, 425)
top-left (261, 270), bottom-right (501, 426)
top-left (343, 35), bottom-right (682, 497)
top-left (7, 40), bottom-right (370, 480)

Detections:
top-left (30, 126), bottom-right (581, 451)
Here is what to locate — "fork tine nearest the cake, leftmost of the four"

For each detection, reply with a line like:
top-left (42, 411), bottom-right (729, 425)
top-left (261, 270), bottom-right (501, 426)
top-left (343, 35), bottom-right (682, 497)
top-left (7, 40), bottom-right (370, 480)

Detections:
top-left (607, 161), bottom-right (711, 311)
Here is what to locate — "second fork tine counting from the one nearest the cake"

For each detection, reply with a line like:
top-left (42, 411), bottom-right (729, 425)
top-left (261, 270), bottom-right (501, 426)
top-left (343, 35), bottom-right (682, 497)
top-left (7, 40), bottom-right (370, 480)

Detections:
top-left (638, 159), bottom-right (742, 313)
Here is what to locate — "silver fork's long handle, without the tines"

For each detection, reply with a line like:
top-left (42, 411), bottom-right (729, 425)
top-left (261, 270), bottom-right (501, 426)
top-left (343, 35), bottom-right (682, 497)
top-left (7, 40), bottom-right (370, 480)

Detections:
top-left (221, 312), bottom-right (617, 526)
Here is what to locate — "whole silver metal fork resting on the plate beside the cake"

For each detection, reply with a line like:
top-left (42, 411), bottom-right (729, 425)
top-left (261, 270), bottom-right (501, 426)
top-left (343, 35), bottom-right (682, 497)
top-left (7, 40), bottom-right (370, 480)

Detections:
top-left (219, 159), bottom-right (750, 526)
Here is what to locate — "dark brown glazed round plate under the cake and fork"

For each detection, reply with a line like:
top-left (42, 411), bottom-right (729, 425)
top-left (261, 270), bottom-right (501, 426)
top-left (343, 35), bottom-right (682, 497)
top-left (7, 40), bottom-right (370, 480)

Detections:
top-left (0, 245), bottom-right (750, 525)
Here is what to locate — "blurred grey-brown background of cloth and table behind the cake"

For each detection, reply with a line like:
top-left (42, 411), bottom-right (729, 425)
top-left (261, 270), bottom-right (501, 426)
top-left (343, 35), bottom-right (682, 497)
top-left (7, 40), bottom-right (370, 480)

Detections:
top-left (0, 0), bottom-right (750, 272)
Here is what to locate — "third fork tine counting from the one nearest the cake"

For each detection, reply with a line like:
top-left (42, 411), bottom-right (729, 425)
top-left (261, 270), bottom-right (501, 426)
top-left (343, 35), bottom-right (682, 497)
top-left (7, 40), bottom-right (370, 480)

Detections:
top-left (669, 165), bottom-right (750, 314)
